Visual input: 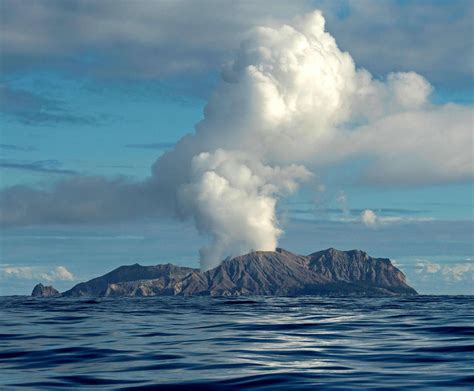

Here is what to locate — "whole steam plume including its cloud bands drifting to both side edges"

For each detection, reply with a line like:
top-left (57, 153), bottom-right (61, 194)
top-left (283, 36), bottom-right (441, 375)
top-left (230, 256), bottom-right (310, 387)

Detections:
top-left (0, 11), bottom-right (474, 269)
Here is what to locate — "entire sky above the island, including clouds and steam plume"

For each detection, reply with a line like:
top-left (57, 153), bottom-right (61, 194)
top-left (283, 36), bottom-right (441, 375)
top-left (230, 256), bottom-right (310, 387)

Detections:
top-left (0, 0), bottom-right (474, 295)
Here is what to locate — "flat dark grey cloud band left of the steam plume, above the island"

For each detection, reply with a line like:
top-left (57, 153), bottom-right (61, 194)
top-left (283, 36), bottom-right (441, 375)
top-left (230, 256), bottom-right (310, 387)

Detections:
top-left (0, 177), bottom-right (165, 226)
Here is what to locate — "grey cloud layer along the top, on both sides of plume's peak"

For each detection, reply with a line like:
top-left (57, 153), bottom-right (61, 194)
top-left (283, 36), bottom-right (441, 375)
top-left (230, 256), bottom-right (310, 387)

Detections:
top-left (0, 0), bottom-right (474, 89)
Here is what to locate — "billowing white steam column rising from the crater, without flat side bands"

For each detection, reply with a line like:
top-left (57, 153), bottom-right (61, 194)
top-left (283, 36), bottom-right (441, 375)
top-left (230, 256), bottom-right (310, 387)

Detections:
top-left (154, 11), bottom-right (448, 270)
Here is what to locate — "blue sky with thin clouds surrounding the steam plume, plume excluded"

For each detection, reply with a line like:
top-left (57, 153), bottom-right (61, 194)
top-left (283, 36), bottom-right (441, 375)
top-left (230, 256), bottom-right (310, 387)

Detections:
top-left (0, 1), bottom-right (474, 295)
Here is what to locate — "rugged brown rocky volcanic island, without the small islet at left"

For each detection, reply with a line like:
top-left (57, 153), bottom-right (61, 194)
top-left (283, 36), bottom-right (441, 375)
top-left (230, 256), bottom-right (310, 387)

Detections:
top-left (35, 249), bottom-right (417, 297)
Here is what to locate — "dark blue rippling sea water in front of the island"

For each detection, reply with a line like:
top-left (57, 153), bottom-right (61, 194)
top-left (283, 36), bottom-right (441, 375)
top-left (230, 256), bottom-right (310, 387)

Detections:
top-left (0, 296), bottom-right (474, 390)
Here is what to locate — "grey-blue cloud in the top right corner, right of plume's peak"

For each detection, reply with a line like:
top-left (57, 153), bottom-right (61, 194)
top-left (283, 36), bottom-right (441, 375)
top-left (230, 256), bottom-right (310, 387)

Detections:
top-left (322, 0), bottom-right (474, 89)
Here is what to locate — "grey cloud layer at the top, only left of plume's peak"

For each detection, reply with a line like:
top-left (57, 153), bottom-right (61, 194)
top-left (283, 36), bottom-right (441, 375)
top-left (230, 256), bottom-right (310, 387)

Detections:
top-left (0, 0), bottom-right (310, 79)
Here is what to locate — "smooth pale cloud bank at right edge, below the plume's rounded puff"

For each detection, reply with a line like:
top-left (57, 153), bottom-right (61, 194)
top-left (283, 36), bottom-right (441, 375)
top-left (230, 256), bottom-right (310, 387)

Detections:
top-left (347, 104), bottom-right (474, 186)
